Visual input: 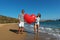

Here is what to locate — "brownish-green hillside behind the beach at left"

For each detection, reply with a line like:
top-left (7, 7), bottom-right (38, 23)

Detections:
top-left (0, 15), bottom-right (18, 23)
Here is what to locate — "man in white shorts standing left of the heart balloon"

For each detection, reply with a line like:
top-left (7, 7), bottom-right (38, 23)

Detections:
top-left (18, 10), bottom-right (24, 33)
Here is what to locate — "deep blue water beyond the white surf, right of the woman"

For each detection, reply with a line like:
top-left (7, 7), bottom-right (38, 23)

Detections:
top-left (41, 21), bottom-right (60, 28)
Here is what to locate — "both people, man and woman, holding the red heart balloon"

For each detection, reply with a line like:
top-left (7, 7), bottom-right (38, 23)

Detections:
top-left (18, 10), bottom-right (41, 34)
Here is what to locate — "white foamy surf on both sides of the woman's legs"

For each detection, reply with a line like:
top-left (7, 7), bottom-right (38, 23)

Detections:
top-left (25, 24), bottom-right (60, 39)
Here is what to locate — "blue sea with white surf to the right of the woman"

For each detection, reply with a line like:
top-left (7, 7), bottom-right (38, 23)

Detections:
top-left (40, 21), bottom-right (60, 40)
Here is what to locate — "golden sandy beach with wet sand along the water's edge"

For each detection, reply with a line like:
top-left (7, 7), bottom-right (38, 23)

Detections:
top-left (0, 23), bottom-right (57, 40)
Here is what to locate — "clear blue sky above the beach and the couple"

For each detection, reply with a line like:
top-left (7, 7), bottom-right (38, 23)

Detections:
top-left (0, 0), bottom-right (60, 20)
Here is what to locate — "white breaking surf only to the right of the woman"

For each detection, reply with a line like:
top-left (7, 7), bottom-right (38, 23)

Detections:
top-left (40, 27), bottom-right (60, 39)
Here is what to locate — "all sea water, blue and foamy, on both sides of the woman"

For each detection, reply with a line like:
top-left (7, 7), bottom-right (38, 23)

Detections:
top-left (25, 21), bottom-right (60, 40)
